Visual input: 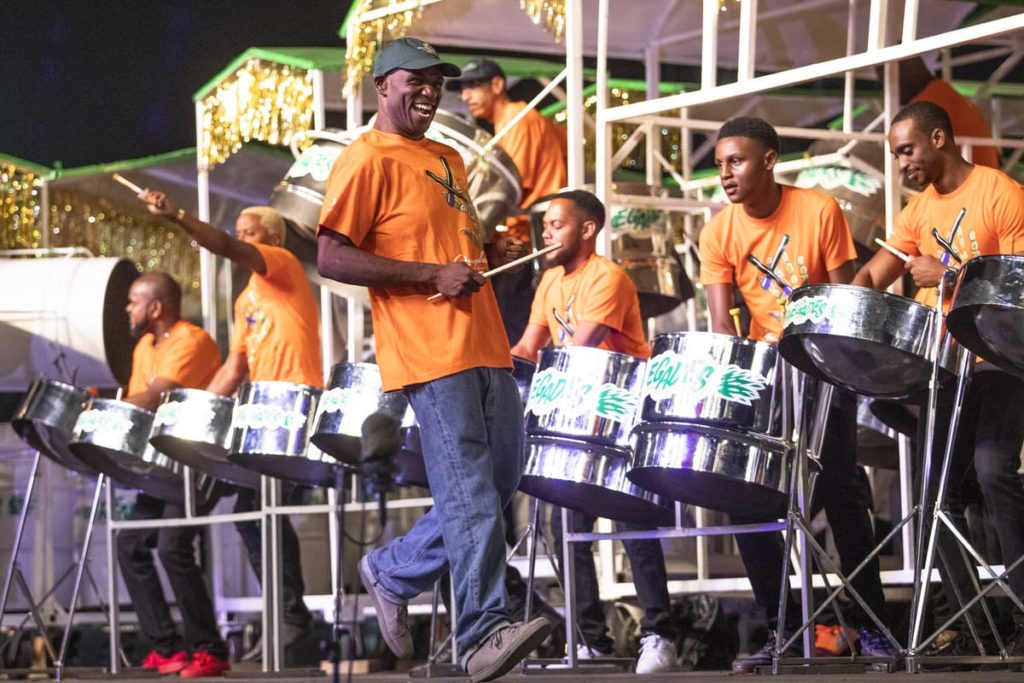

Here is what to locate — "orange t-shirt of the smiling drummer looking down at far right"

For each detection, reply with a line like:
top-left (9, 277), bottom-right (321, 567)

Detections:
top-left (886, 166), bottom-right (1024, 306)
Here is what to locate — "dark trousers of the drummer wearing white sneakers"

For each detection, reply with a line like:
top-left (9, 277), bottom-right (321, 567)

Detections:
top-left (551, 506), bottom-right (676, 652)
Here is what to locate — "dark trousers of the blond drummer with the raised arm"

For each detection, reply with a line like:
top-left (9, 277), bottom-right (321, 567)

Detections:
top-left (234, 482), bottom-right (312, 628)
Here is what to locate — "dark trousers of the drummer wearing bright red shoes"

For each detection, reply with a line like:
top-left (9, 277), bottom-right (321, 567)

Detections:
top-left (118, 494), bottom-right (227, 659)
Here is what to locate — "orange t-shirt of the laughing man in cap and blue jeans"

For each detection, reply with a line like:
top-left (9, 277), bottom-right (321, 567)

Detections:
top-left (319, 129), bottom-right (512, 391)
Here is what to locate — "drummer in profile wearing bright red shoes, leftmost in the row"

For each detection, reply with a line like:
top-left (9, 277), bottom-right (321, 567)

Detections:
top-left (117, 271), bottom-right (229, 678)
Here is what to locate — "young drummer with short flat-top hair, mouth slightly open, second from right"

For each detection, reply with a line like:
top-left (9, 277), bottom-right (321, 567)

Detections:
top-left (700, 117), bottom-right (899, 672)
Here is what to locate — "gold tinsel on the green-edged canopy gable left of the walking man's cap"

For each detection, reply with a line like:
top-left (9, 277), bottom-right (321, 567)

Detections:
top-left (199, 58), bottom-right (313, 171)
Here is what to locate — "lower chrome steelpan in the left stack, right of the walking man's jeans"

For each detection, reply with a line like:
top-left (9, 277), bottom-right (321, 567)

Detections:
top-left (519, 436), bottom-right (675, 526)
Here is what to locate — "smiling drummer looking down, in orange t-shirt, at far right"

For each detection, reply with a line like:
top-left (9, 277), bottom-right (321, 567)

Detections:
top-left (853, 101), bottom-right (1024, 656)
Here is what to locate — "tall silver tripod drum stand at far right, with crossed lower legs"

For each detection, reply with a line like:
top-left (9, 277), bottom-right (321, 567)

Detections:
top-left (906, 284), bottom-right (1024, 673)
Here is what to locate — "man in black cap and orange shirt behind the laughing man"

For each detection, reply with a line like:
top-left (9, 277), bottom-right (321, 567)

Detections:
top-left (444, 59), bottom-right (568, 343)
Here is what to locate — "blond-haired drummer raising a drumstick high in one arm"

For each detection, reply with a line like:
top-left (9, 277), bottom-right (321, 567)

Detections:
top-left (139, 189), bottom-right (324, 659)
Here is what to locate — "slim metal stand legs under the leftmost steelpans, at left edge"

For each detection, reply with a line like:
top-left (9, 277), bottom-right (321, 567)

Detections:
top-left (0, 451), bottom-right (127, 680)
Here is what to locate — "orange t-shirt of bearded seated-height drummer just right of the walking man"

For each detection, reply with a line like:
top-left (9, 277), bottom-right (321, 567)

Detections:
top-left (529, 254), bottom-right (650, 359)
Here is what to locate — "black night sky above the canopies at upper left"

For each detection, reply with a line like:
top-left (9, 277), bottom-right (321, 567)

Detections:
top-left (0, 0), bottom-right (350, 168)
